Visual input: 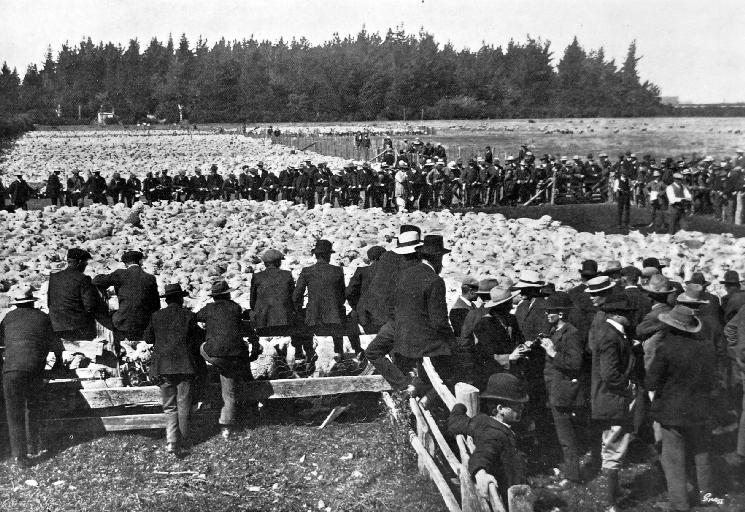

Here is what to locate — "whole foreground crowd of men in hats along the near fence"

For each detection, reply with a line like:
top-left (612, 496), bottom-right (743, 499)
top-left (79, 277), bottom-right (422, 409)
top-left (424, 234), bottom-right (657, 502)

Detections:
top-left (0, 225), bottom-right (745, 511)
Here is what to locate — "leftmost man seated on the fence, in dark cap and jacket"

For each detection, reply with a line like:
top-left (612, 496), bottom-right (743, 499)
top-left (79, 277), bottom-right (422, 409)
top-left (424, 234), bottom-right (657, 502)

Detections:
top-left (47, 247), bottom-right (104, 348)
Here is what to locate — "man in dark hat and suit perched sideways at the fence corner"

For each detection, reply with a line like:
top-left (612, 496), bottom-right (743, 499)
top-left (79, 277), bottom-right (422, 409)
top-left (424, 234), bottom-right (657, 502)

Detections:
top-left (392, 235), bottom-right (455, 404)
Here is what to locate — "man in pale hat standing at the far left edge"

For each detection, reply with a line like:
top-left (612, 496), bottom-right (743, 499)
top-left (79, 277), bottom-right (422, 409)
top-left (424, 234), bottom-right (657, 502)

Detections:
top-left (0, 285), bottom-right (56, 467)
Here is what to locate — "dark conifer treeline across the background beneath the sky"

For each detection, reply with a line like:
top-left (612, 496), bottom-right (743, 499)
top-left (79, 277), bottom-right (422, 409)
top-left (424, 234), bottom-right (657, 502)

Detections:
top-left (0, 29), bottom-right (673, 124)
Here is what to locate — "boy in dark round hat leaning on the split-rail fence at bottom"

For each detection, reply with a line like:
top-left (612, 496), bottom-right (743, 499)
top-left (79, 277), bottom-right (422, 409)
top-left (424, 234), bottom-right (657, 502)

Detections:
top-left (448, 373), bottom-right (529, 503)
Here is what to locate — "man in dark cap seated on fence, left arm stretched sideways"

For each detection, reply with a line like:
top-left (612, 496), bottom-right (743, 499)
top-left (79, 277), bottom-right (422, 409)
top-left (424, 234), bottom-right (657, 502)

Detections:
top-left (93, 251), bottom-right (160, 341)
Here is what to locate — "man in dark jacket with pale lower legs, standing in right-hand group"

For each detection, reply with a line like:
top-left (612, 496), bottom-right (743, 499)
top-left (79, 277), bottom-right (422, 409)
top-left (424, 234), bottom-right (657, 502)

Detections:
top-left (588, 292), bottom-right (636, 510)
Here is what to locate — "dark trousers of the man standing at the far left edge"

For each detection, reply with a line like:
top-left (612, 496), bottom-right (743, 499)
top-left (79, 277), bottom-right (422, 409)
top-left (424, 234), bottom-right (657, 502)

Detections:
top-left (3, 371), bottom-right (44, 457)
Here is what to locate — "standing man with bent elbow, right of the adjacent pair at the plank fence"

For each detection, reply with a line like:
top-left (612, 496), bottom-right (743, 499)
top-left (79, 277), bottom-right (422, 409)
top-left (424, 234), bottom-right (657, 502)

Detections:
top-left (197, 280), bottom-right (262, 440)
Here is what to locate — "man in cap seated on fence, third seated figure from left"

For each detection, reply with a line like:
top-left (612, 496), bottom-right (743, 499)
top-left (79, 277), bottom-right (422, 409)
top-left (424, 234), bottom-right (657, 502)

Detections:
top-left (251, 249), bottom-right (317, 367)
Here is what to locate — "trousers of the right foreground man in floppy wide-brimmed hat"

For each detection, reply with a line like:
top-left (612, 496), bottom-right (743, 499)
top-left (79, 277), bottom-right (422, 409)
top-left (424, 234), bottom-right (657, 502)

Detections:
top-left (661, 425), bottom-right (712, 510)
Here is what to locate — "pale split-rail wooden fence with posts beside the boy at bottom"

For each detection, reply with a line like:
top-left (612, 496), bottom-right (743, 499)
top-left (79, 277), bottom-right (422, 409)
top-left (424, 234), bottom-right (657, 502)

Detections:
top-left (383, 358), bottom-right (533, 512)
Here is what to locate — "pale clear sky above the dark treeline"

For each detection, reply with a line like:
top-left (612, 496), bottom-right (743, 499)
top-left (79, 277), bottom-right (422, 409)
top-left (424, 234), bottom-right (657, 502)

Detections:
top-left (0, 0), bottom-right (745, 103)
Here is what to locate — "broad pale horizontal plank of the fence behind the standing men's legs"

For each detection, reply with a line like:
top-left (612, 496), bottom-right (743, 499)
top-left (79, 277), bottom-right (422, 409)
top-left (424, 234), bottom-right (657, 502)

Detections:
top-left (78, 375), bottom-right (391, 409)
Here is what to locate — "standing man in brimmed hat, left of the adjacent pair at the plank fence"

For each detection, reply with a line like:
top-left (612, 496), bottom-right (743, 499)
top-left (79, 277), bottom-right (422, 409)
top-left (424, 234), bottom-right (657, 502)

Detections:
top-left (143, 284), bottom-right (205, 453)
